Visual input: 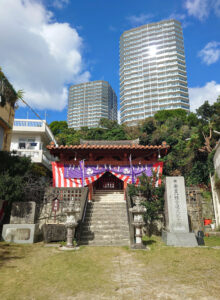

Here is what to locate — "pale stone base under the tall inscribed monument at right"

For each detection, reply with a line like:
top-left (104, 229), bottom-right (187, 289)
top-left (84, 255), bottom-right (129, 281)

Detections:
top-left (162, 230), bottom-right (198, 247)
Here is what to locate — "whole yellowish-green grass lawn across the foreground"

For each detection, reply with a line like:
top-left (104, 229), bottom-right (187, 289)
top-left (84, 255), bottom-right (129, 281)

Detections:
top-left (0, 236), bottom-right (220, 300)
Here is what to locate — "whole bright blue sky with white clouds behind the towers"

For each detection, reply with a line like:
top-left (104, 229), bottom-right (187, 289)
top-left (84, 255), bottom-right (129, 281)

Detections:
top-left (0, 0), bottom-right (220, 123)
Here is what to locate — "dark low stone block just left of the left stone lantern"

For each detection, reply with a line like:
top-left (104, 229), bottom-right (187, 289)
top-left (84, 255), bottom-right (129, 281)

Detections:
top-left (42, 224), bottom-right (66, 243)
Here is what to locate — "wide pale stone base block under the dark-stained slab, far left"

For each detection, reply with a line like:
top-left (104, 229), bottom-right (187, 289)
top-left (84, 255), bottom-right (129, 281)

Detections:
top-left (2, 224), bottom-right (41, 244)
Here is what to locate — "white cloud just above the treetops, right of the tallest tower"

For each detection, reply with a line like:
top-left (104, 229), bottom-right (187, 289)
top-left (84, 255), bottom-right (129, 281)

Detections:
top-left (189, 81), bottom-right (220, 112)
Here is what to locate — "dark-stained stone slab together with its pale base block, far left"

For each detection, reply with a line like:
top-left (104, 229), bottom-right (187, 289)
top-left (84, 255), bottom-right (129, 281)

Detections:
top-left (2, 201), bottom-right (40, 244)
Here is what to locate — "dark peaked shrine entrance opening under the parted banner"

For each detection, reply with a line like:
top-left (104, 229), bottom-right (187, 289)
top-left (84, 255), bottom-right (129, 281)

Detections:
top-left (93, 172), bottom-right (124, 190)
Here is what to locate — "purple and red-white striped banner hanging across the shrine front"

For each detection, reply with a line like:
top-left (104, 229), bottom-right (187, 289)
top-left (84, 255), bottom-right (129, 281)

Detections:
top-left (52, 162), bottom-right (163, 187)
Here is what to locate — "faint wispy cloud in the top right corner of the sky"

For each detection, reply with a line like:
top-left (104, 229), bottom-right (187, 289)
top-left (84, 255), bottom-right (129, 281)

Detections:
top-left (184, 0), bottom-right (220, 21)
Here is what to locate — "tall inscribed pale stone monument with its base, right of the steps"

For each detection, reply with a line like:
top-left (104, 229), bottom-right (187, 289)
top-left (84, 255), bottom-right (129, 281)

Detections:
top-left (162, 176), bottom-right (198, 247)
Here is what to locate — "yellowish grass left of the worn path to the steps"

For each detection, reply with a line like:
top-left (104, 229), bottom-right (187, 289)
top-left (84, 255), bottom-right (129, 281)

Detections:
top-left (0, 243), bottom-right (117, 299)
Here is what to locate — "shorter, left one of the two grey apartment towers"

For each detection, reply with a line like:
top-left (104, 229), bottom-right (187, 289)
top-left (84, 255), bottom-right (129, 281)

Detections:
top-left (68, 80), bottom-right (117, 129)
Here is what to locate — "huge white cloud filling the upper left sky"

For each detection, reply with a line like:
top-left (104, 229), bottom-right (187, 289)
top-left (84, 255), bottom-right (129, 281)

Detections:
top-left (0, 0), bottom-right (90, 110)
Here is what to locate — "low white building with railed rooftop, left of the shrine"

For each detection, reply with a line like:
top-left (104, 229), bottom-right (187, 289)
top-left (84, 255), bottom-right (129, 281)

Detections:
top-left (10, 119), bottom-right (57, 170)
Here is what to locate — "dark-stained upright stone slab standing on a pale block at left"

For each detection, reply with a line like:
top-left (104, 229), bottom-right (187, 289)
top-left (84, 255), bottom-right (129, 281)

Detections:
top-left (10, 201), bottom-right (36, 224)
